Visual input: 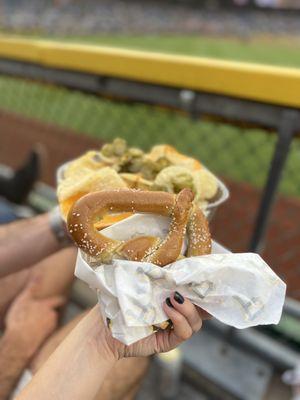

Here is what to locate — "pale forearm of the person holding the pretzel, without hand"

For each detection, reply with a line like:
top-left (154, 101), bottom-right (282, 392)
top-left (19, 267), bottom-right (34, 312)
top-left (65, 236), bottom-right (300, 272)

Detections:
top-left (18, 307), bottom-right (115, 400)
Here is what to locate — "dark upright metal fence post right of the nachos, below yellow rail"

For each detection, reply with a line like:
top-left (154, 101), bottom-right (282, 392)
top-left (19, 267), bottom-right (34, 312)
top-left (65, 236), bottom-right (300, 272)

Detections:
top-left (249, 109), bottom-right (300, 253)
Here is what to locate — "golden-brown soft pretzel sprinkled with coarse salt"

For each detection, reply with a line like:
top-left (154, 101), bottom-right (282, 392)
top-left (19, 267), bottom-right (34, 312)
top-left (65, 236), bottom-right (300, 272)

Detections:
top-left (67, 189), bottom-right (211, 266)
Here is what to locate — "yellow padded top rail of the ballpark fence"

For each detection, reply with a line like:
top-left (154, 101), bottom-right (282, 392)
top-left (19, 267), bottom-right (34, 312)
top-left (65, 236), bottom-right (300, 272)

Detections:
top-left (0, 37), bottom-right (300, 107)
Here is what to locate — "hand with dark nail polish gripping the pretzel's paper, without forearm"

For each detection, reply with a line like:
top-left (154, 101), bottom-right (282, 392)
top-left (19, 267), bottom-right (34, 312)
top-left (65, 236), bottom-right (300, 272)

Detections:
top-left (101, 292), bottom-right (210, 359)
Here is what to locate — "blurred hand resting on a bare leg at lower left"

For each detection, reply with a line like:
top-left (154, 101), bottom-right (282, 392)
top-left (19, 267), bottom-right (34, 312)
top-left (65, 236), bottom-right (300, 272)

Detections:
top-left (5, 282), bottom-right (65, 357)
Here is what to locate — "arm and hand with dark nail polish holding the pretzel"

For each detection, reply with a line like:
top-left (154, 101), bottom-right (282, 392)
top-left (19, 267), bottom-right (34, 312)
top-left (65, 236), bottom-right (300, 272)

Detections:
top-left (10, 293), bottom-right (206, 400)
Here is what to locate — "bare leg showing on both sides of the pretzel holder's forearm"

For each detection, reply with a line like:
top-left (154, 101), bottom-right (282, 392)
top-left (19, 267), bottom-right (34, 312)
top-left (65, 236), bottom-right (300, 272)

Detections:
top-left (30, 313), bottom-right (149, 400)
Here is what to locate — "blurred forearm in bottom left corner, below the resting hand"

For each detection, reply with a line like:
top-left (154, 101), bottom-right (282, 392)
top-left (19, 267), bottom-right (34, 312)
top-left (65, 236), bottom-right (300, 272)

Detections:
top-left (0, 333), bottom-right (31, 400)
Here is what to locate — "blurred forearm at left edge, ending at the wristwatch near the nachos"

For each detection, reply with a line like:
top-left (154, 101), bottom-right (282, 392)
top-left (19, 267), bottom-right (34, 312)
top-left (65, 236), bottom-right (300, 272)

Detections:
top-left (0, 214), bottom-right (61, 278)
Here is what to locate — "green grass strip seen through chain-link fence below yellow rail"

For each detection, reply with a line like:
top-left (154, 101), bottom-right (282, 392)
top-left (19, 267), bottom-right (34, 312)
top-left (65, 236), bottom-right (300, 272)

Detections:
top-left (0, 76), bottom-right (300, 198)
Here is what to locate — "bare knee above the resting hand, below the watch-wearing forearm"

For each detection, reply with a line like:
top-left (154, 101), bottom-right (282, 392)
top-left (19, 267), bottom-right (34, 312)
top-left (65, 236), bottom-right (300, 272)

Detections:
top-left (0, 247), bottom-right (76, 326)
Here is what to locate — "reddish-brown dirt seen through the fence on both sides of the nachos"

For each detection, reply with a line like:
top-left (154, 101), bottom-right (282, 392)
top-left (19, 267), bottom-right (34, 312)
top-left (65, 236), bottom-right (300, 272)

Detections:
top-left (0, 112), bottom-right (300, 299)
